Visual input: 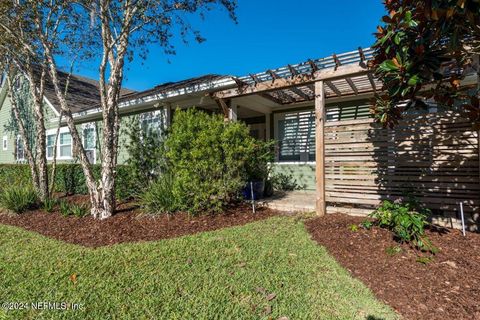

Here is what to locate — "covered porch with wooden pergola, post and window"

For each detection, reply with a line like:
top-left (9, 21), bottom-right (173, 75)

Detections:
top-left (212, 48), bottom-right (381, 215)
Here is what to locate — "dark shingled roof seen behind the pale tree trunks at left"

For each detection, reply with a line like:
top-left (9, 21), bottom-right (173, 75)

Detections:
top-left (44, 71), bottom-right (135, 113)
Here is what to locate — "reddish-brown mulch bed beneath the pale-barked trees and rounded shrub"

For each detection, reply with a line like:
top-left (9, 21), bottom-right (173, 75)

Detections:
top-left (0, 197), bottom-right (278, 247)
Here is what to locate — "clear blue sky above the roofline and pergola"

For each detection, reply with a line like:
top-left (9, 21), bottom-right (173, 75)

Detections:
top-left (73, 0), bottom-right (384, 90)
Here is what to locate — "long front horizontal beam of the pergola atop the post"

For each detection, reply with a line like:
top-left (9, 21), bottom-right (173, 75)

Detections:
top-left (214, 64), bottom-right (369, 99)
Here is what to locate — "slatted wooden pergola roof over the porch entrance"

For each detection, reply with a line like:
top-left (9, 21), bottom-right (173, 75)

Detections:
top-left (214, 48), bottom-right (382, 105)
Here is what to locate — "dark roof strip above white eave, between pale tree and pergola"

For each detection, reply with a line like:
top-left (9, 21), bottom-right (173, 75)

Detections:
top-left (121, 74), bottom-right (231, 100)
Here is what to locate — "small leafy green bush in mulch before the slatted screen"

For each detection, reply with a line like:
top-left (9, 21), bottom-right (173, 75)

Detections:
top-left (370, 199), bottom-right (438, 253)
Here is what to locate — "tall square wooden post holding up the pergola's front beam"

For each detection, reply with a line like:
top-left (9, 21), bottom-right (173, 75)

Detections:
top-left (315, 81), bottom-right (326, 216)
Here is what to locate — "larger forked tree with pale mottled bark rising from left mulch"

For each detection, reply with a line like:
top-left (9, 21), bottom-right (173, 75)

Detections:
top-left (7, 0), bottom-right (236, 219)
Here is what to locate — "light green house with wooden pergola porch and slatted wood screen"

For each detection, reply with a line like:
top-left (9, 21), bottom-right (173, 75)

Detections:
top-left (0, 49), bottom-right (480, 226)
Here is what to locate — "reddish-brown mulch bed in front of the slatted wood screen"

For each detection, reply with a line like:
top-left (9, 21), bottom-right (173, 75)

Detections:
top-left (306, 214), bottom-right (480, 319)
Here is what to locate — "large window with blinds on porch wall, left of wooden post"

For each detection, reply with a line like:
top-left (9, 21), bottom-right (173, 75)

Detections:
top-left (274, 110), bottom-right (315, 161)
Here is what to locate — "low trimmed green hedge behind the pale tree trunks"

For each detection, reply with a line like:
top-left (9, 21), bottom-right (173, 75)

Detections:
top-left (0, 163), bottom-right (136, 199)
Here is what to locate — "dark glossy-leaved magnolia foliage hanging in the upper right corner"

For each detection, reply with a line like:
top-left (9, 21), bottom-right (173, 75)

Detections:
top-left (370, 0), bottom-right (480, 128)
